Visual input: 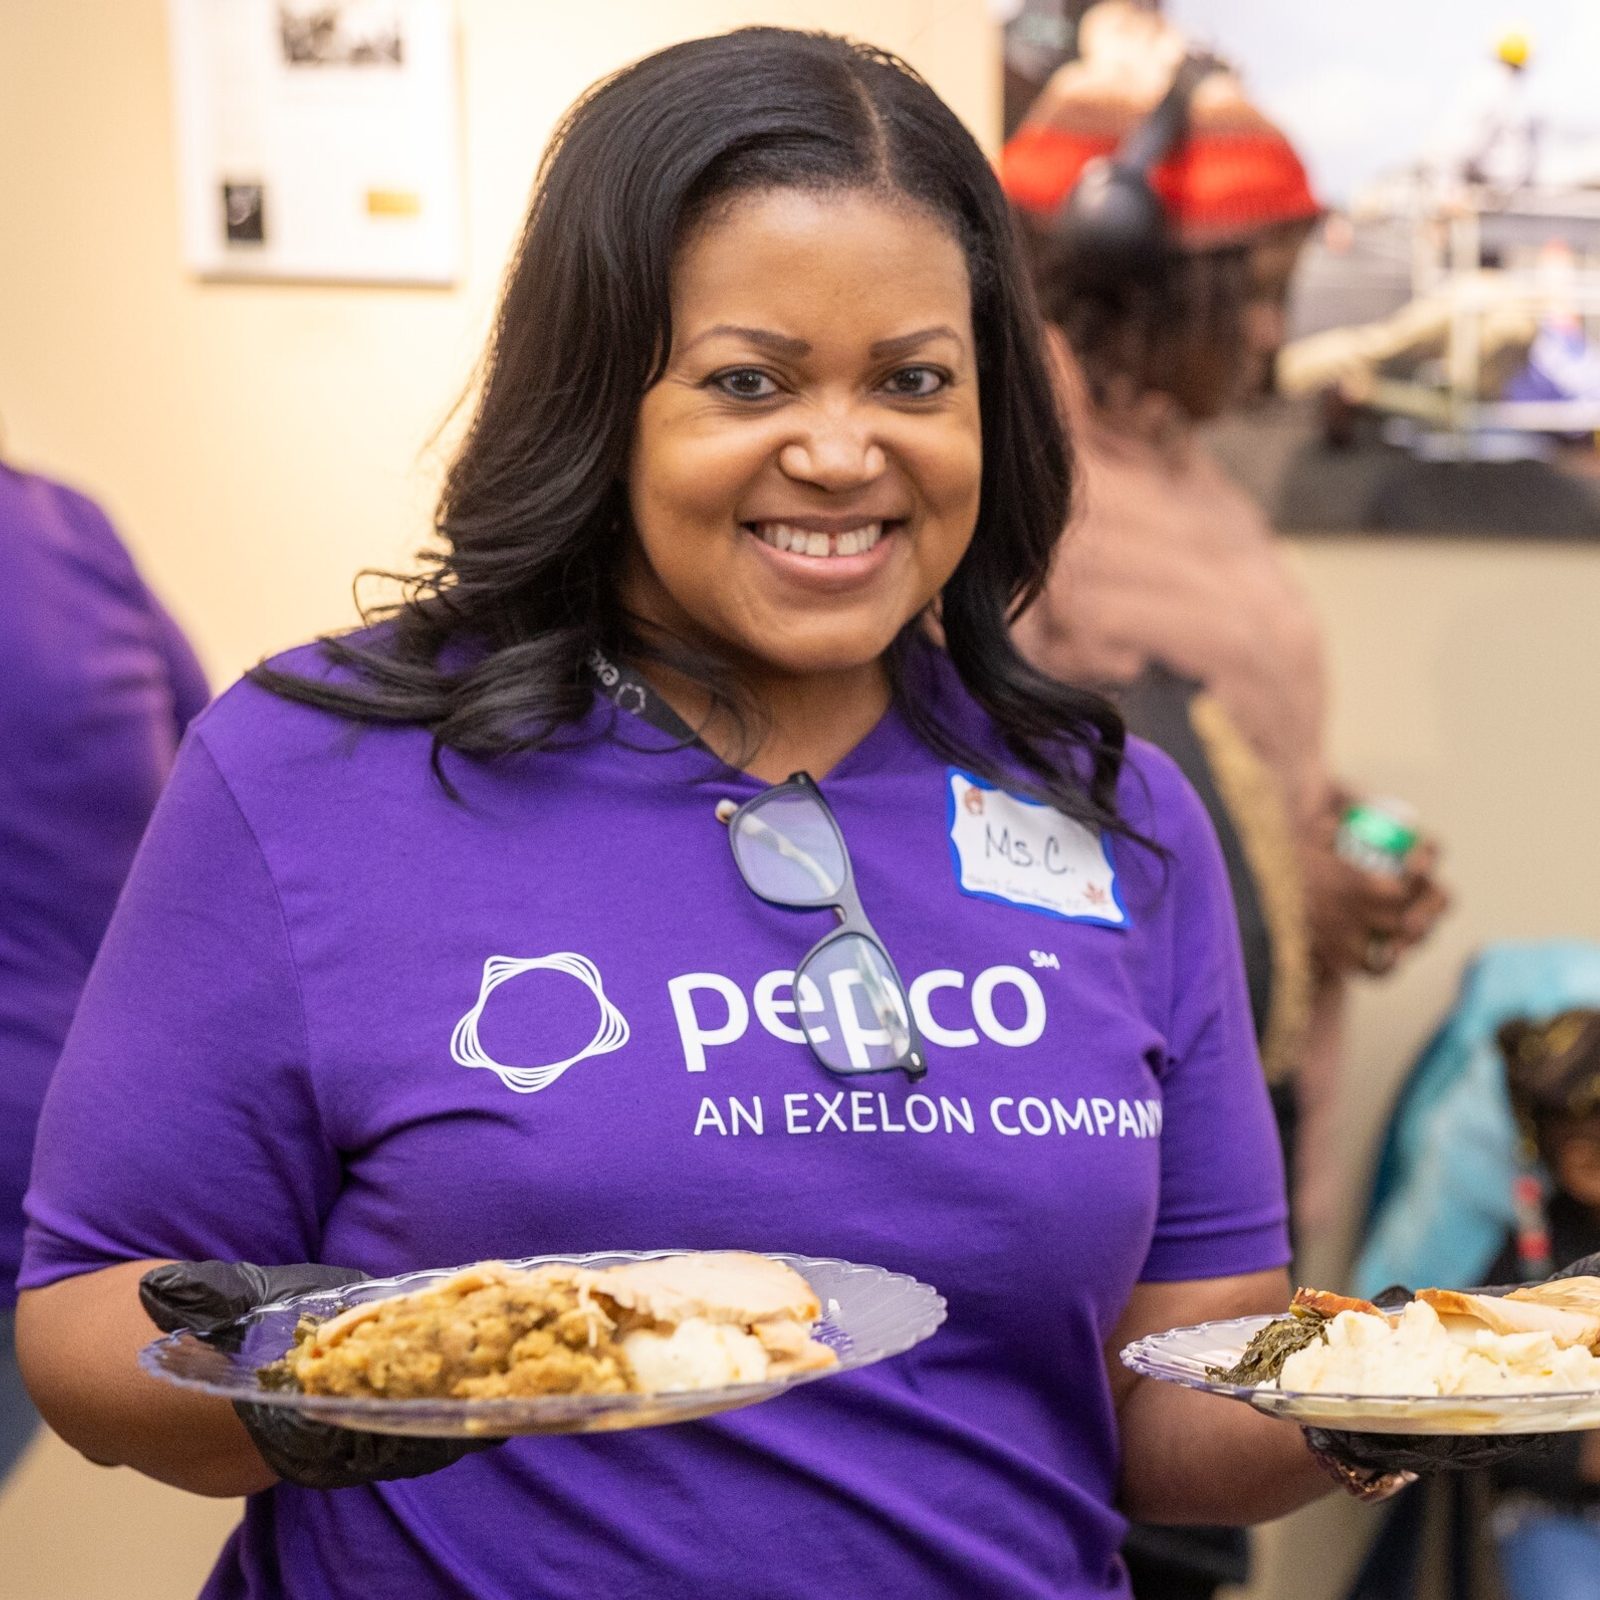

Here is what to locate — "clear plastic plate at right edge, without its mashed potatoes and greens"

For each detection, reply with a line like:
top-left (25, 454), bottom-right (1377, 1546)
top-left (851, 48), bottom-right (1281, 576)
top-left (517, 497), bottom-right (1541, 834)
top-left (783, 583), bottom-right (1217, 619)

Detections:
top-left (1122, 1317), bottom-right (1600, 1434)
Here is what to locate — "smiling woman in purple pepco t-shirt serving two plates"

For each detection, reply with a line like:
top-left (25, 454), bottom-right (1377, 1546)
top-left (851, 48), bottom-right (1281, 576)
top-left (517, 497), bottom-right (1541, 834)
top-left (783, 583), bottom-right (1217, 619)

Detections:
top-left (9, 29), bottom-right (1376, 1600)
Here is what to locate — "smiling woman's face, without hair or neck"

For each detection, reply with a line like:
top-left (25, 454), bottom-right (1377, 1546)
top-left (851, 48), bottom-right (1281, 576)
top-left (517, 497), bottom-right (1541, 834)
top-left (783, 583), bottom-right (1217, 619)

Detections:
top-left (624, 189), bottom-right (982, 677)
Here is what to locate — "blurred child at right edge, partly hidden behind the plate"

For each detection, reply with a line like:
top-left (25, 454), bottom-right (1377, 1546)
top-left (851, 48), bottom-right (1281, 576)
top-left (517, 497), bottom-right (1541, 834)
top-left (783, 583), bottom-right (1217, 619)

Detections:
top-left (1490, 1010), bottom-right (1600, 1600)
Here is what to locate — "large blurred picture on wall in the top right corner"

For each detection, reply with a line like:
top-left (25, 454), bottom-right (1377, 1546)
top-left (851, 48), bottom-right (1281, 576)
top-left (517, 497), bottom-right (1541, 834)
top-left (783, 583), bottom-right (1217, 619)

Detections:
top-left (1165, 0), bottom-right (1600, 539)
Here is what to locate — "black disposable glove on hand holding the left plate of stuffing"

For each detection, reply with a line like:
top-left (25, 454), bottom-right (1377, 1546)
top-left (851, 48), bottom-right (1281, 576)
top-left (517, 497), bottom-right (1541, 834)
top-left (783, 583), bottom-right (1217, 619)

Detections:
top-left (139, 1261), bottom-right (501, 1490)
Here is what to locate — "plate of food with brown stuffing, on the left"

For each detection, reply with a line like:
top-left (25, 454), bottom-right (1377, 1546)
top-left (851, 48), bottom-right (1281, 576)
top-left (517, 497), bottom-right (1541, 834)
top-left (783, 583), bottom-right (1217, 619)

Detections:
top-left (139, 1250), bottom-right (944, 1438)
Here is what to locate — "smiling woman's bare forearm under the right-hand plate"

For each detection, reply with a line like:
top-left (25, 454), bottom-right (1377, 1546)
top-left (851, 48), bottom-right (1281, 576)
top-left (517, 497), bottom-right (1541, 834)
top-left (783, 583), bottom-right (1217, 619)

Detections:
top-left (1122, 1381), bottom-right (1333, 1525)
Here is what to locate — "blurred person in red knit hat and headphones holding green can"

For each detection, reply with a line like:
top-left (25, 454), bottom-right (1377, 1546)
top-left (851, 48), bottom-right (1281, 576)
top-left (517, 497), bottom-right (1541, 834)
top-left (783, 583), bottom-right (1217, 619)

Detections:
top-left (1002, 0), bottom-right (1445, 1597)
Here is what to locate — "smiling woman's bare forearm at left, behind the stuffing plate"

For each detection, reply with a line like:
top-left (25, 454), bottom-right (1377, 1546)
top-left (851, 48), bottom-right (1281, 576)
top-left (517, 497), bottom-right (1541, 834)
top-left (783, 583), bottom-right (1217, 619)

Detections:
top-left (16, 1261), bottom-right (277, 1496)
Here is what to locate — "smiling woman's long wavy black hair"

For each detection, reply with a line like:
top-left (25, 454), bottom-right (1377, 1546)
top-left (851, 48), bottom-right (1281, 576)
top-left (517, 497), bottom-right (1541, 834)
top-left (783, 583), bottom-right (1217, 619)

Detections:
top-left (253, 27), bottom-right (1125, 830)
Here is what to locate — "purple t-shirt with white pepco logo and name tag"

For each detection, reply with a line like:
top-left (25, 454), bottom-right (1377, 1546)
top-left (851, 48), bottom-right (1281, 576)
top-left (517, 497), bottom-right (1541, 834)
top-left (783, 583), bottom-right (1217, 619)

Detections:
top-left (24, 640), bottom-right (1288, 1600)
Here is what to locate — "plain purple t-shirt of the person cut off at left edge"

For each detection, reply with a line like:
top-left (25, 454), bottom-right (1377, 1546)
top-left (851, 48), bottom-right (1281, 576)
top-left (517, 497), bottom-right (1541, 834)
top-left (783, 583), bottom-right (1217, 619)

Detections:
top-left (0, 466), bottom-right (206, 1309)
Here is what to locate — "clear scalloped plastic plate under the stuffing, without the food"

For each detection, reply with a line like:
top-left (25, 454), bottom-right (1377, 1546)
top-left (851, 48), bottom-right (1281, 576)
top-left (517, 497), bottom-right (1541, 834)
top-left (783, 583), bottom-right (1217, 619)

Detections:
top-left (139, 1250), bottom-right (944, 1438)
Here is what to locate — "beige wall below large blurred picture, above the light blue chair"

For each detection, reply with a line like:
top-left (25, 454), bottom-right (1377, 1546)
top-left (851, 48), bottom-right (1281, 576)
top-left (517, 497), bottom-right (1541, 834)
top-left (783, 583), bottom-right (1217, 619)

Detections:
top-left (1294, 538), bottom-right (1600, 1273)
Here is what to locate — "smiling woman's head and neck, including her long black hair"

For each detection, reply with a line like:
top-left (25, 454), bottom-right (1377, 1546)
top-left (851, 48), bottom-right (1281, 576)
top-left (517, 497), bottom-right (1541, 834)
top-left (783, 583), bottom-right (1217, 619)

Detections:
top-left (254, 29), bottom-right (1122, 829)
